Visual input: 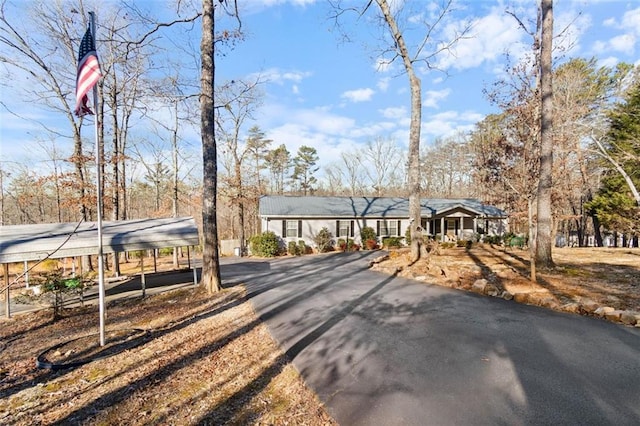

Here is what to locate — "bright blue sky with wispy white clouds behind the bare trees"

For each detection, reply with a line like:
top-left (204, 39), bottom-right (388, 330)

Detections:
top-left (0, 0), bottom-right (640, 181)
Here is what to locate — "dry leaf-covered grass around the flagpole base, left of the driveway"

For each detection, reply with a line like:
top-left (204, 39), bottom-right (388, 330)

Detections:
top-left (0, 287), bottom-right (336, 425)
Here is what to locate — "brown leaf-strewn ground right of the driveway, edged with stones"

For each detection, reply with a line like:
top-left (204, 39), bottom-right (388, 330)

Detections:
top-left (373, 245), bottom-right (640, 320)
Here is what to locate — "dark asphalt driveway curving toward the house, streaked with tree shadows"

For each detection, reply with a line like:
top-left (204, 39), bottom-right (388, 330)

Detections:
top-left (222, 252), bottom-right (640, 426)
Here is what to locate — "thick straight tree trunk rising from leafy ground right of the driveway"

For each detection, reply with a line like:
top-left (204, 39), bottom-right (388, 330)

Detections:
top-left (535, 0), bottom-right (553, 268)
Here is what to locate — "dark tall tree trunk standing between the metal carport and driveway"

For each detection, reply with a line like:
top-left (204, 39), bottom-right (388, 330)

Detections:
top-left (200, 0), bottom-right (221, 293)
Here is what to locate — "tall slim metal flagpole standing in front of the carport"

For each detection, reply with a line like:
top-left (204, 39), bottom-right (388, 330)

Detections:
top-left (89, 12), bottom-right (105, 346)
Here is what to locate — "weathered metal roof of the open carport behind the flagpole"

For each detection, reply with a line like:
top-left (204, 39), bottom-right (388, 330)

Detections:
top-left (0, 217), bottom-right (200, 264)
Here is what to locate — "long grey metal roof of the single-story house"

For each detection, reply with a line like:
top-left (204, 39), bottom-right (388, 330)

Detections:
top-left (260, 195), bottom-right (507, 218)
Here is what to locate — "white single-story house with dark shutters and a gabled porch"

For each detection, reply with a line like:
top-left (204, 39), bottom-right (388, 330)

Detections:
top-left (259, 195), bottom-right (507, 246)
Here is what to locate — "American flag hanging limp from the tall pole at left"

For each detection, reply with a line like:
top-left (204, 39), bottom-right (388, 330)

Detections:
top-left (75, 28), bottom-right (102, 117)
